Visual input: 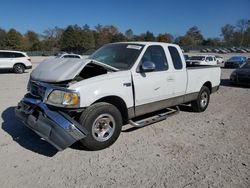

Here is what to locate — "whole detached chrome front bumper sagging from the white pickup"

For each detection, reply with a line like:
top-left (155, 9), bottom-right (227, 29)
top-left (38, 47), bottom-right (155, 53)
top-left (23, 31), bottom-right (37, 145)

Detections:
top-left (15, 97), bottom-right (88, 150)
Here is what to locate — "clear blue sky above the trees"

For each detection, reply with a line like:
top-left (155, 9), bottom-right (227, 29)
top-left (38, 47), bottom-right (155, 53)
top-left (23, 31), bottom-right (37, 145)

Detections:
top-left (0, 0), bottom-right (250, 38)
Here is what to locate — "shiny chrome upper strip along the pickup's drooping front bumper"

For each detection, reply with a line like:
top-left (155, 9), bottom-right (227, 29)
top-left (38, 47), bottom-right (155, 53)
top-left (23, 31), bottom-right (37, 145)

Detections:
top-left (22, 97), bottom-right (85, 140)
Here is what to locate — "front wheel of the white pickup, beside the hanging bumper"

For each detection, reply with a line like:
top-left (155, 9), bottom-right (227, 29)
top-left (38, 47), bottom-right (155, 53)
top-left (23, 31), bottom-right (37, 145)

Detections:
top-left (79, 102), bottom-right (122, 150)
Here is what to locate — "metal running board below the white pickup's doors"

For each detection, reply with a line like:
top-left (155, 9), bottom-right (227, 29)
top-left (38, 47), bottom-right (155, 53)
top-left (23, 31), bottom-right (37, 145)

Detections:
top-left (128, 106), bottom-right (180, 128)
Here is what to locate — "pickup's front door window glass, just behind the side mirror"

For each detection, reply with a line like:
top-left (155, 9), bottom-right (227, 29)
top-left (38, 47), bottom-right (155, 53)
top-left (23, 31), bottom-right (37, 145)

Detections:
top-left (142, 46), bottom-right (168, 71)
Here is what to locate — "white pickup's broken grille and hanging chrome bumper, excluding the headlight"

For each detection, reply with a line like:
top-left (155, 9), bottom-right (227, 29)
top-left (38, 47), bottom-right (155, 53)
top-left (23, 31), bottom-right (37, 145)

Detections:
top-left (15, 81), bottom-right (88, 150)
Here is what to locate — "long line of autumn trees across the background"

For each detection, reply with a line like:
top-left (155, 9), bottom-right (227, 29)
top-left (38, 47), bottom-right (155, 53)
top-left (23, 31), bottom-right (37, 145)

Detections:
top-left (0, 19), bottom-right (250, 53)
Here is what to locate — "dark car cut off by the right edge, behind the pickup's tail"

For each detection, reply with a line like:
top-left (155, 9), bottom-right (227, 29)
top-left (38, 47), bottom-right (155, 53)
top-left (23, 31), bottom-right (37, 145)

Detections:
top-left (230, 60), bottom-right (250, 85)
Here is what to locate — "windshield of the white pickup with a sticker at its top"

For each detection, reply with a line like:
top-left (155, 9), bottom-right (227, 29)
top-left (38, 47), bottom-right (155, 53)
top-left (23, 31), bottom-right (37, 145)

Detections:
top-left (88, 43), bottom-right (144, 70)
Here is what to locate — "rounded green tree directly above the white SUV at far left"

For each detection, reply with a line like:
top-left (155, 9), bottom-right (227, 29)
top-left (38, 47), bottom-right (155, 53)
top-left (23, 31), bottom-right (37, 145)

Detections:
top-left (4, 29), bottom-right (23, 50)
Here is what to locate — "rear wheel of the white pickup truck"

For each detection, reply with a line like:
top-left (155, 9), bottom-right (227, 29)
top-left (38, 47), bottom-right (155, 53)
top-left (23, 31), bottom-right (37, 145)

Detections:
top-left (191, 86), bottom-right (210, 112)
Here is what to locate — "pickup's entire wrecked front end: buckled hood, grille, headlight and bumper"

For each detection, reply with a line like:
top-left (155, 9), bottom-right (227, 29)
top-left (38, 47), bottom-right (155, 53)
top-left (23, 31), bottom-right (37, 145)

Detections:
top-left (15, 59), bottom-right (115, 150)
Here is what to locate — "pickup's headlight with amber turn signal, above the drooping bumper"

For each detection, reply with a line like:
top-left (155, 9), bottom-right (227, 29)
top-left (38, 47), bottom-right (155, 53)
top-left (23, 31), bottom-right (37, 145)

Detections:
top-left (47, 90), bottom-right (80, 107)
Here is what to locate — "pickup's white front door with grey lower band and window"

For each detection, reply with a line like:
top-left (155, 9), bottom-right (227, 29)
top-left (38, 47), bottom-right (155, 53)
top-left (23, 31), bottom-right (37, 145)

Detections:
top-left (133, 45), bottom-right (174, 115)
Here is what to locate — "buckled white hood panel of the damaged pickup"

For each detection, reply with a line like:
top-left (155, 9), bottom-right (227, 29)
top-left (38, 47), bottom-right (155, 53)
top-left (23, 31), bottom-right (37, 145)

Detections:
top-left (31, 58), bottom-right (91, 82)
